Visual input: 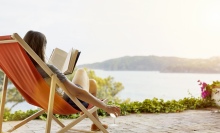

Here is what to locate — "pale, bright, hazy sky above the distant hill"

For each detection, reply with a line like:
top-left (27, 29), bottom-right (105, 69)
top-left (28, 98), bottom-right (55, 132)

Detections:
top-left (0, 0), bottom-right (220, 65)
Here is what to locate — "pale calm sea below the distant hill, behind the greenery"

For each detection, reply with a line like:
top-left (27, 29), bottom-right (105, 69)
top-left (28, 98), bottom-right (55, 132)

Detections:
top-left (6, 70), bottom-right (220, 112)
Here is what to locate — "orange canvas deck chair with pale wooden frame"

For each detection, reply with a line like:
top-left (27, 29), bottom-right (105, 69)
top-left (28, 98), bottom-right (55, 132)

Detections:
top-left (0, 33), bottom-right (108, 133)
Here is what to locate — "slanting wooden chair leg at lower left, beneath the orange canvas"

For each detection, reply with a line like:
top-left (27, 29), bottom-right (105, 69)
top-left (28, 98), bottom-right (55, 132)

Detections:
top-left (7, 110), bottom-right (45, 132)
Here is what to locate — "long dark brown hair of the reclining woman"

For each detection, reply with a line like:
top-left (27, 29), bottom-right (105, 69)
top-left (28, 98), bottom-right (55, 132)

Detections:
top-left (23, 30), bottom-right (47, 65)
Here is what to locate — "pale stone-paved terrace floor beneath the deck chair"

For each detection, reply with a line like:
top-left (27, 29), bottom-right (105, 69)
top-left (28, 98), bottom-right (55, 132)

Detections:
top-left (3, 110), bottom-right (220, 133)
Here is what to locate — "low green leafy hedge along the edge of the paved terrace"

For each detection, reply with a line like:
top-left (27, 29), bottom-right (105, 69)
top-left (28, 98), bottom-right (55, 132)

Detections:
top-left (3, 97), bottom-right (219, 121)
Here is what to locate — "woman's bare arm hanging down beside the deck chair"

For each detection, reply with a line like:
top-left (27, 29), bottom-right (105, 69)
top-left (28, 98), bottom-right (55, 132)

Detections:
top-left (63, 80), bottom-right (120, 116)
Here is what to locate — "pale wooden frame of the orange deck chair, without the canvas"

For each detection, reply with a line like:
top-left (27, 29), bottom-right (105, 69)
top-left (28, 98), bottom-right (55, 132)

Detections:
top-left (0, 33), bottom-right (108, 133)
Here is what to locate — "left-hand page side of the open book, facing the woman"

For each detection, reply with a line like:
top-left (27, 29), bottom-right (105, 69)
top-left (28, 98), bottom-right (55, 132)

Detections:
top-left (48, 48), bottom-right (67, 72)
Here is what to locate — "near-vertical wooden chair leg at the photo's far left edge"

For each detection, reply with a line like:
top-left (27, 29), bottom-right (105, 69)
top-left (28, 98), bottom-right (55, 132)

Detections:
top-left (0, 74), bottom-right (8, 132)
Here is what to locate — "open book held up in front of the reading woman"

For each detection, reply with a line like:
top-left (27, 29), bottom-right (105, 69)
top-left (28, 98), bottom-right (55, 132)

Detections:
top-left (48, 48), bottom-right (81, 75)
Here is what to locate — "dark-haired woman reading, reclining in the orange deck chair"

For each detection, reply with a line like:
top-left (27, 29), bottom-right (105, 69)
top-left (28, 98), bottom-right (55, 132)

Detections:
top-left (24, 30), bottom-right (120, 131)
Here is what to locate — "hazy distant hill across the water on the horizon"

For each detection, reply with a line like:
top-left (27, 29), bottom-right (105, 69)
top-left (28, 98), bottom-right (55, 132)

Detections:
top-left (78, 56), bottom-right (220, 73)
